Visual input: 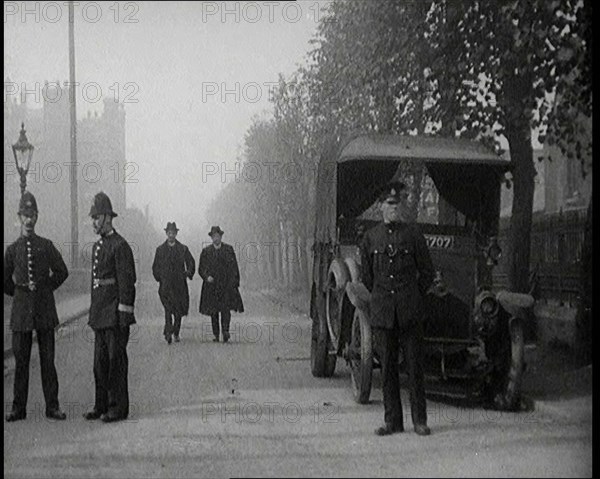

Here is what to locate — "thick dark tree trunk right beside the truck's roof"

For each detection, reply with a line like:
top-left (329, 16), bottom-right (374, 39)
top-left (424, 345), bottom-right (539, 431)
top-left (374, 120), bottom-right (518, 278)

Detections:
top-left (507, 126), bottom-right (535, 293)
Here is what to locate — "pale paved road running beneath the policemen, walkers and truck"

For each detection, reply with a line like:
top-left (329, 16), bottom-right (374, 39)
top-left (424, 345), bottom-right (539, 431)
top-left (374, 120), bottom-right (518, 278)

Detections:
top-left (4, 281), bottom-right (592, 478)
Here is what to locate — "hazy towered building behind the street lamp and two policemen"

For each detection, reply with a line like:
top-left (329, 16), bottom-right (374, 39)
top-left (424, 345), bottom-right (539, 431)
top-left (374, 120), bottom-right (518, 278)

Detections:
top-left (4, 82), bottom-right (126, 266)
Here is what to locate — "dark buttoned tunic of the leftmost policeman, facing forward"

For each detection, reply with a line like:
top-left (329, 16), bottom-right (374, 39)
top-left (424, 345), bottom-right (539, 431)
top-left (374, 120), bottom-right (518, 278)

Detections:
top-left (4, 234), bottom-right (69, 331)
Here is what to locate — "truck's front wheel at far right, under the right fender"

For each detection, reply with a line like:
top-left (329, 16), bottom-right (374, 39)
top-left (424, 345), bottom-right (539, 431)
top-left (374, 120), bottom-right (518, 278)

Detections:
top-left (492, 319), bottom-right (525, 411)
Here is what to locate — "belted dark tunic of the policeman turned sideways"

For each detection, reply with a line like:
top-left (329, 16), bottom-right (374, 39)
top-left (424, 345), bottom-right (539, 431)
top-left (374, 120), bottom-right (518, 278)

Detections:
top-left (88, 230), bottom-right (136, 330)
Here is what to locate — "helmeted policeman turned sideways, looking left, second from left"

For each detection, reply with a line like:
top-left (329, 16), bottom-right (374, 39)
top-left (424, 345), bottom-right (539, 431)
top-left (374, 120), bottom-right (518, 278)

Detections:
top-left (84, 192), bottom-right (136, 422)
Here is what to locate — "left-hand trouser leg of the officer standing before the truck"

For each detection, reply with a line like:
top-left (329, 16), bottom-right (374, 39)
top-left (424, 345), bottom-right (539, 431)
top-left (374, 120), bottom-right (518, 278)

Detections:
top-left (373, 328), bottom-right (404, 428)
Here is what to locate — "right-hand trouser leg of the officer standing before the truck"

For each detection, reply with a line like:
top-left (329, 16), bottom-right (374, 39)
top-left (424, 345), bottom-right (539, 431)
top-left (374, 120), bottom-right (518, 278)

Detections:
top-left (403, 323), bottom-right (427, 425)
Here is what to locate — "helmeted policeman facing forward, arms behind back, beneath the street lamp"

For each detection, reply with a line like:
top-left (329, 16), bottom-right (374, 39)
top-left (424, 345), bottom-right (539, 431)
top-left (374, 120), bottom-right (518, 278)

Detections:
top-left (4, 191), bottom-right (69, 422)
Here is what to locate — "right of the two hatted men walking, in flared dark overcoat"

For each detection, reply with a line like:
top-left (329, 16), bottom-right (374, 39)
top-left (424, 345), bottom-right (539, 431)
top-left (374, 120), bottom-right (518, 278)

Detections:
top-left (198, 226), bottom-right (244, 343)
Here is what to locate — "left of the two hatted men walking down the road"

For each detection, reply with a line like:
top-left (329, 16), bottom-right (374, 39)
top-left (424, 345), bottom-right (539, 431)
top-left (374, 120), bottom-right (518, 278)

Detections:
top-left (152, 222), bottom-right (196, 344)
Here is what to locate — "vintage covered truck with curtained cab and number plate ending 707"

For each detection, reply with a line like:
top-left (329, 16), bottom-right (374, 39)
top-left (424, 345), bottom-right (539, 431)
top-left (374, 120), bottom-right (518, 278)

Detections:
top-left (310, 134), bottom-right (533, 410)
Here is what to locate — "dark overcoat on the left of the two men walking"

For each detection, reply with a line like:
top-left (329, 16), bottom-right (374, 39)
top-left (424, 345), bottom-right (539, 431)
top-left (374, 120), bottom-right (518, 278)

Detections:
top-left (152, 240), bottom-right (196, 316)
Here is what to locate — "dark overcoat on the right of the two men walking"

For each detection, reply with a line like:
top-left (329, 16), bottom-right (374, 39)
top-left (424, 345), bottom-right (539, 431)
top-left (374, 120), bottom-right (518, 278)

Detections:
top-left (198, 243), bottom-right (244, 316)
